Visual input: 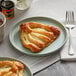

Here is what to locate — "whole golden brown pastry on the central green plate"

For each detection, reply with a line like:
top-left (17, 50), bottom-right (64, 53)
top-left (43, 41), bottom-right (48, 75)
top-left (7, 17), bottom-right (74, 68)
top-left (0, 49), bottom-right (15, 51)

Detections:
top-left (20, 22), bottom-right (60, 52)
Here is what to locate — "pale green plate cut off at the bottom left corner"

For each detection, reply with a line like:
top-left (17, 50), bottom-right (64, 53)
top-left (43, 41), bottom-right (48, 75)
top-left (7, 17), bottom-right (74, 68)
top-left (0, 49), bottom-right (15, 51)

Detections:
top-left (0, 57), bottom-right (33, 76)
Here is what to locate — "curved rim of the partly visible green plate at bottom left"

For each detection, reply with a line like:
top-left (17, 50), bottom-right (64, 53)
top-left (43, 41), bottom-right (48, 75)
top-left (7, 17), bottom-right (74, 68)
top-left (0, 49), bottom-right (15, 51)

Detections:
top-left (0, 57), bottom-right (33, 76)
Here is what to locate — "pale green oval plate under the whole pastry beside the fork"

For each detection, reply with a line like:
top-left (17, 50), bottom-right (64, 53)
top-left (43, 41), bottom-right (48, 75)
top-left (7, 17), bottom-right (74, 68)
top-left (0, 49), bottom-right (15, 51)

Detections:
top-left (9, 17), bottom-right (67, 56)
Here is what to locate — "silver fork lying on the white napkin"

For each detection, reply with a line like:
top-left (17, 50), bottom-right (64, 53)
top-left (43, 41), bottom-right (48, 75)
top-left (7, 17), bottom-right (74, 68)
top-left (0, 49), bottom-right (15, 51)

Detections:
top-left (66, 11), bottom-right (75, 55)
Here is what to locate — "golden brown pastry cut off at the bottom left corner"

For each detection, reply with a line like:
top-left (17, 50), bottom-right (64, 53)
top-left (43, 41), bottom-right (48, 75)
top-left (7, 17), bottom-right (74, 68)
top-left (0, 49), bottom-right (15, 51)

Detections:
top-left (0, 60), bottom-right (24, 76)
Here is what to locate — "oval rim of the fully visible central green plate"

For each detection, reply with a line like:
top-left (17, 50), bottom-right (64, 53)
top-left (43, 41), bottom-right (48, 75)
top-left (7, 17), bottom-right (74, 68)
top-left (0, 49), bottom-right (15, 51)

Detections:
top-left (9, 16), bottom-right (68, 56)
